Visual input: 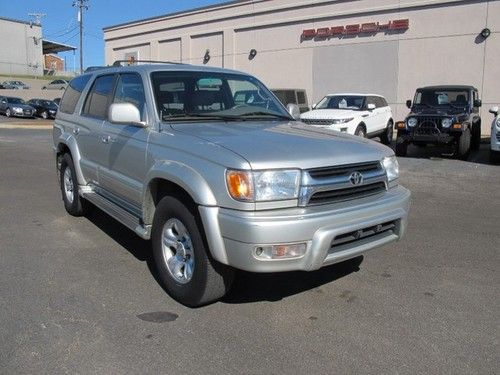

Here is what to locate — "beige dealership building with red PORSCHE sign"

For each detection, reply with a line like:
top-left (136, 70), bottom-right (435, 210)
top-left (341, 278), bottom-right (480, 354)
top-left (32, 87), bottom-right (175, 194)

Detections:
top-left (104, 0), bottom-right (500, 134)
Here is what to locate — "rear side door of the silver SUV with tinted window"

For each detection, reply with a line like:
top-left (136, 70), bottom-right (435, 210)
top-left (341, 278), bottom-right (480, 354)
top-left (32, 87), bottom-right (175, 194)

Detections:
top-left (77, 74), bottom-right (115, 186)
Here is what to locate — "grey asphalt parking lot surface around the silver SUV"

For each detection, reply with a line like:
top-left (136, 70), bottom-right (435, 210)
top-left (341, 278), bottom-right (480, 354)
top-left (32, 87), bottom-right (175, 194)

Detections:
top-left (0, 124), bottom-right (500, 374)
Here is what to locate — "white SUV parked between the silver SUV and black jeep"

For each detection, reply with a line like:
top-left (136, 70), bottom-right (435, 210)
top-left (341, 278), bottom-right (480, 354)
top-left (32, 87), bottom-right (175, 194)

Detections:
top-left (300, 94), bottom-right (394, 144)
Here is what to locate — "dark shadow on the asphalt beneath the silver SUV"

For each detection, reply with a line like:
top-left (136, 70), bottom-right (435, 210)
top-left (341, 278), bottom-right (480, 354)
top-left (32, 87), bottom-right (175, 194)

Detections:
top-left (87, 207), bottom-right (363, 304)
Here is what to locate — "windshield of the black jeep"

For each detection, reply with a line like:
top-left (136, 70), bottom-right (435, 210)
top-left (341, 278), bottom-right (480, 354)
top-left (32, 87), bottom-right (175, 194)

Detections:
top-left (413, 89), bottom-right (469, 108)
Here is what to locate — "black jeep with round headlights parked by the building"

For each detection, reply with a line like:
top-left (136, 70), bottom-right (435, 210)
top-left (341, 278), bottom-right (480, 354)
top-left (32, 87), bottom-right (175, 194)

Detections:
top-left (396, 86), bottom-right (481, 159)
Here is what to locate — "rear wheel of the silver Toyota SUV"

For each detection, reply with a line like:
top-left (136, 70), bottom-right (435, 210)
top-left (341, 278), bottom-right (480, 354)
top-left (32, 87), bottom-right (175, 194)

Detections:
top-left (59, 154), bottom-right (88, 216)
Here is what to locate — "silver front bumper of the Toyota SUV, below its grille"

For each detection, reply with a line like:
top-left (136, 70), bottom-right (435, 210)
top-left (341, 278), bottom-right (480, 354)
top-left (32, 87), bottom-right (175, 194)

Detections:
top-left (200, 186), bottom-right (410, 272)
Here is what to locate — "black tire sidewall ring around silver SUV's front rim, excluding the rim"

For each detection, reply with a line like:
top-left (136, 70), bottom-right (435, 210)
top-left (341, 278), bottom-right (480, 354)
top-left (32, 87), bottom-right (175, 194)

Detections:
top-left (151, 196), bottom-right (210, 306)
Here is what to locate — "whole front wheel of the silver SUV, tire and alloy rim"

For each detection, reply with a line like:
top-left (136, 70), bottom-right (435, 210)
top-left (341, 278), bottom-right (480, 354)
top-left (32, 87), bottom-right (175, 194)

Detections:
top-left (151, 196), bottom-right (234, 307)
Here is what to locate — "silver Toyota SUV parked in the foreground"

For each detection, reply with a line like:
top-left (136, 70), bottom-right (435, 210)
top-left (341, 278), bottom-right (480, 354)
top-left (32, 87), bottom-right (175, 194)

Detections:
top-left (53, 64), bottom-right (410, 306)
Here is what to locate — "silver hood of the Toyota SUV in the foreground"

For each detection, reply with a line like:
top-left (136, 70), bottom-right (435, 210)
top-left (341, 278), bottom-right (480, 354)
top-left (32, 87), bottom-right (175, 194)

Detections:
top-left (171, 121), bottom-right (394, 169)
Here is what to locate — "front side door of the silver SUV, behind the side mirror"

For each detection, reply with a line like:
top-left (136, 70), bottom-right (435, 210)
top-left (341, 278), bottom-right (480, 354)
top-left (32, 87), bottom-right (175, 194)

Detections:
top-left (100, 73), bottom-right (150, 212)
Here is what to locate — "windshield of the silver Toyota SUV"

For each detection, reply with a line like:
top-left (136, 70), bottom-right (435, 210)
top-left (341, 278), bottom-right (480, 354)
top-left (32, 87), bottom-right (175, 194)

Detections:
top-left (151, 71), bottom-right (291, 121)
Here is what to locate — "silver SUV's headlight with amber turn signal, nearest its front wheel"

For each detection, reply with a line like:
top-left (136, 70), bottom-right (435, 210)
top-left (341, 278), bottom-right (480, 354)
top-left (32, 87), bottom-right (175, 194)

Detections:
top-left (226, 169), bottom-right (300, 202)
